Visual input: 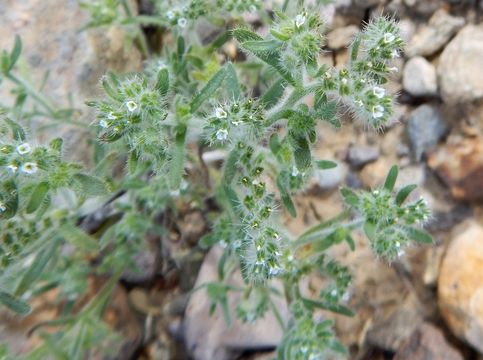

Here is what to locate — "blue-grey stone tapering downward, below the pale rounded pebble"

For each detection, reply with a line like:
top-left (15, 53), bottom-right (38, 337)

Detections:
top-left (407, 105), bottom-right (447, 161)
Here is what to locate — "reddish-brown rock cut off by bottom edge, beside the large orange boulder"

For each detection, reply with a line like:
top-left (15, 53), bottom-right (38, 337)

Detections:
top-left (393, 323), bottom-right (463, 360)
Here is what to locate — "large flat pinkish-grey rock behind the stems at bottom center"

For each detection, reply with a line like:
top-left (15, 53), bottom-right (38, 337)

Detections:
top-left (184, 247), bottom-right (289, 360)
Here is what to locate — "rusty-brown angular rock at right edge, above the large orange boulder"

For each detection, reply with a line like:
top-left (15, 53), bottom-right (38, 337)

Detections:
top-left (428, 136), bottom-right (483, 202)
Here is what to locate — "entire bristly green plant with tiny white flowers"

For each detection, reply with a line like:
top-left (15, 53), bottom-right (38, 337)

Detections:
top-left (0, 0), bottom-right (432, 360)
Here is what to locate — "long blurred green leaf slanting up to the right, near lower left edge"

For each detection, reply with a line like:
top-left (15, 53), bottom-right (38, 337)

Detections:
top-left (15, 234), bottom-right (61, 296)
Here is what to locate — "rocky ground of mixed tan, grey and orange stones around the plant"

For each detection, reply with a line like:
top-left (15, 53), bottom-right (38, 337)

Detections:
top-left (0, 0), bottom-right (483, 360)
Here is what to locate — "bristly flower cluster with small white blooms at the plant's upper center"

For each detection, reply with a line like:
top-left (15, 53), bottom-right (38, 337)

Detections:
top-left (205, 98), bottom-right (266, 145)
